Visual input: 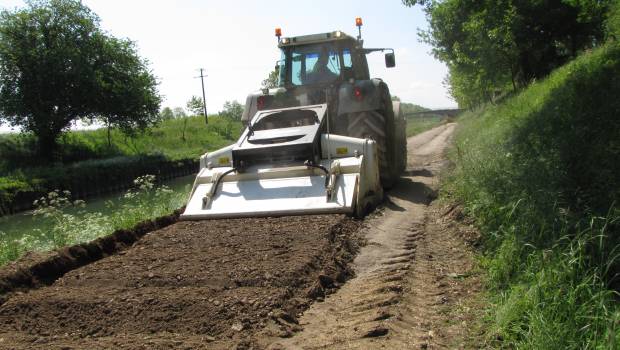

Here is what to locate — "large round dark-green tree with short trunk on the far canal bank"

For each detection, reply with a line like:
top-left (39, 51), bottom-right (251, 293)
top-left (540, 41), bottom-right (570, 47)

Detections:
top-left (0, 0), bottom-right (161, 159)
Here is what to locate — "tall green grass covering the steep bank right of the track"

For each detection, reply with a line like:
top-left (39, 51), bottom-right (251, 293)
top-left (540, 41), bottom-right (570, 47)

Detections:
top-left (444, 42), bottom-right (620, 349)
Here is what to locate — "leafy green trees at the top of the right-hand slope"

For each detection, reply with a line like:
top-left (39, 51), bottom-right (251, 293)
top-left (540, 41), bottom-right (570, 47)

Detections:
top-left (403, 0), bottom-right (612, 107)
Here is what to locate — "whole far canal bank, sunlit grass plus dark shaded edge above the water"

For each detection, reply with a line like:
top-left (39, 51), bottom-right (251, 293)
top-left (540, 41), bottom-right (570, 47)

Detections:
top-left (0, 116), bottom-right (242, 213)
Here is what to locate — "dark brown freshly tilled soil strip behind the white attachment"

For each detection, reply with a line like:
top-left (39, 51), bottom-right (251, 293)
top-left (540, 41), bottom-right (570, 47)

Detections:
top-left (0, 215), bottom-right (359, 349)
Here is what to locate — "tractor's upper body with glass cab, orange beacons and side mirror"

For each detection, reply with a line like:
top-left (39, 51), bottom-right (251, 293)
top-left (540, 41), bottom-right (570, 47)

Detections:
top-left (241, 19), bottom-right (395, 125)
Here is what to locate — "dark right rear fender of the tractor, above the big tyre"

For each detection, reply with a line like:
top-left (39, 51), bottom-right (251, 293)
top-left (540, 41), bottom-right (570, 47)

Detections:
top-left (338, 78), bottom-right (387, 115)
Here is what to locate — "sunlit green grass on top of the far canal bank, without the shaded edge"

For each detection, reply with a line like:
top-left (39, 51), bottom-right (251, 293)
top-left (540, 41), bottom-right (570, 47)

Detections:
top-left (0, 115), bottom-right (242, 170)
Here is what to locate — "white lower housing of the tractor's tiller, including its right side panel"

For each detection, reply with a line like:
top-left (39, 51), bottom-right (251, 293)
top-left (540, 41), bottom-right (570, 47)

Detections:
top-left (181, 135), bottom-right (383, 220)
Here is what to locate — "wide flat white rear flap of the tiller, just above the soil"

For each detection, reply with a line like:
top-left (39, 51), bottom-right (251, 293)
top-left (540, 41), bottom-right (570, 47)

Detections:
top-left (181, 164), bottom-right (359, 220)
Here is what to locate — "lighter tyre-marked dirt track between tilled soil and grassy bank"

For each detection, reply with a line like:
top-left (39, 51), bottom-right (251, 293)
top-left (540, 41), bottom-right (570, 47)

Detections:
top-left (271, 124), bottom-right (480, 349)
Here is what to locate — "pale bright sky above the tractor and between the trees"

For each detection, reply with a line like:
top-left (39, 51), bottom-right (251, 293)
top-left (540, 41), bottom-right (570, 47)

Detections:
top-left (0, 0), bottom-right (456, 130)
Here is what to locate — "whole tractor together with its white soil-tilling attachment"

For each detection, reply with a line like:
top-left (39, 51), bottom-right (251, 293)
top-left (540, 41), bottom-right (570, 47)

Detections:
top-left (181, 18), bottom-right (407, 220)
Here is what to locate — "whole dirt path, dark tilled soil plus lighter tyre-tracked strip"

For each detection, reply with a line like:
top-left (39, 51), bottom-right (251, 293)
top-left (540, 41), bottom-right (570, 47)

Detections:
top-left (0, 124), bottom-right (476, 349)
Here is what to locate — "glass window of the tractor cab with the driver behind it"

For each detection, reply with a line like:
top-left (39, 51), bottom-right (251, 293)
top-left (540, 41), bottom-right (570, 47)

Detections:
top-left (281, 44), bottom-right (350, 86)
